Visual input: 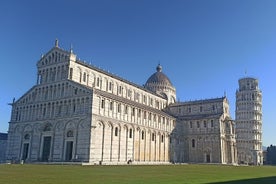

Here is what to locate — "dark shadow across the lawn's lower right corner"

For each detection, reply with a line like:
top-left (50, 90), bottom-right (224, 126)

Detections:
top-left (209, 176), bottom-right (276, 184)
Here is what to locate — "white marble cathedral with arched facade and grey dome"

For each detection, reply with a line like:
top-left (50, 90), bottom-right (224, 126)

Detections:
top-left (7, 40), bottom-right (260, 165)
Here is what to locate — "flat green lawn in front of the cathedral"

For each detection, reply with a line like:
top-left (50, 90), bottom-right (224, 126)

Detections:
top-left (0, 164), bottom-right (276, 184)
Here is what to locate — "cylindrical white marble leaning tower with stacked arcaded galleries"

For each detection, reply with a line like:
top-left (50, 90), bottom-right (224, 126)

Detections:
top-left (236, 77), bottom-right (263, 165)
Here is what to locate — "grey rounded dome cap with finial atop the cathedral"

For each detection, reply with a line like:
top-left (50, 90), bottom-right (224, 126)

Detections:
top-left (145, 64), bottom-right (173, 86)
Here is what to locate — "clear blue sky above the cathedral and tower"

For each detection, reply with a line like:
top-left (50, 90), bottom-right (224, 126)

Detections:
top-left (0, 0), bottom-right (276, 146)
